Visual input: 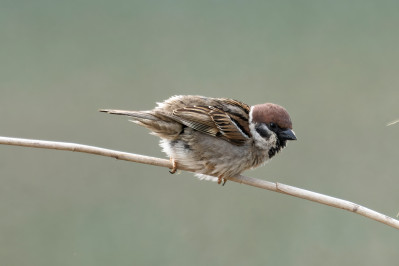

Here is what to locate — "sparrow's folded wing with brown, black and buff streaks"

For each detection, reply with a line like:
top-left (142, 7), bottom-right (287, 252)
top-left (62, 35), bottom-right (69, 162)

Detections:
top-left (172, 106), bottom-right (249, 145)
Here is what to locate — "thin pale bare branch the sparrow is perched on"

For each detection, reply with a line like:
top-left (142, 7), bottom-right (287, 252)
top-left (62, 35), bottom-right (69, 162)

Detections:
top-left (0, 137), bottom-right (399, 229)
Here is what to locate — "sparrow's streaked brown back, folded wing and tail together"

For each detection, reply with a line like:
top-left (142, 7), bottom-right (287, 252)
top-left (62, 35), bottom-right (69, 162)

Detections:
top-left (100, 96), bottom-right (251, 146)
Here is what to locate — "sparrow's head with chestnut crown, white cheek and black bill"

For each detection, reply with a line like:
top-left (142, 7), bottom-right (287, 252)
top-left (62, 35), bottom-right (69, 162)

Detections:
top-left (250, 103), bottom-right (296, 158)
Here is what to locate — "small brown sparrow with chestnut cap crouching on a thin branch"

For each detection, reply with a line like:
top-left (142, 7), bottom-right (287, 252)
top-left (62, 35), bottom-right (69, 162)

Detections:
top-left (99, 95), bottom-right (297, 185)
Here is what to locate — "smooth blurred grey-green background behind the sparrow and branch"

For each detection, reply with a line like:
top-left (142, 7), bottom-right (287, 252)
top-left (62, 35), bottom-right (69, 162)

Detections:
top-left (0, 0), bottom-right (399, 265)
